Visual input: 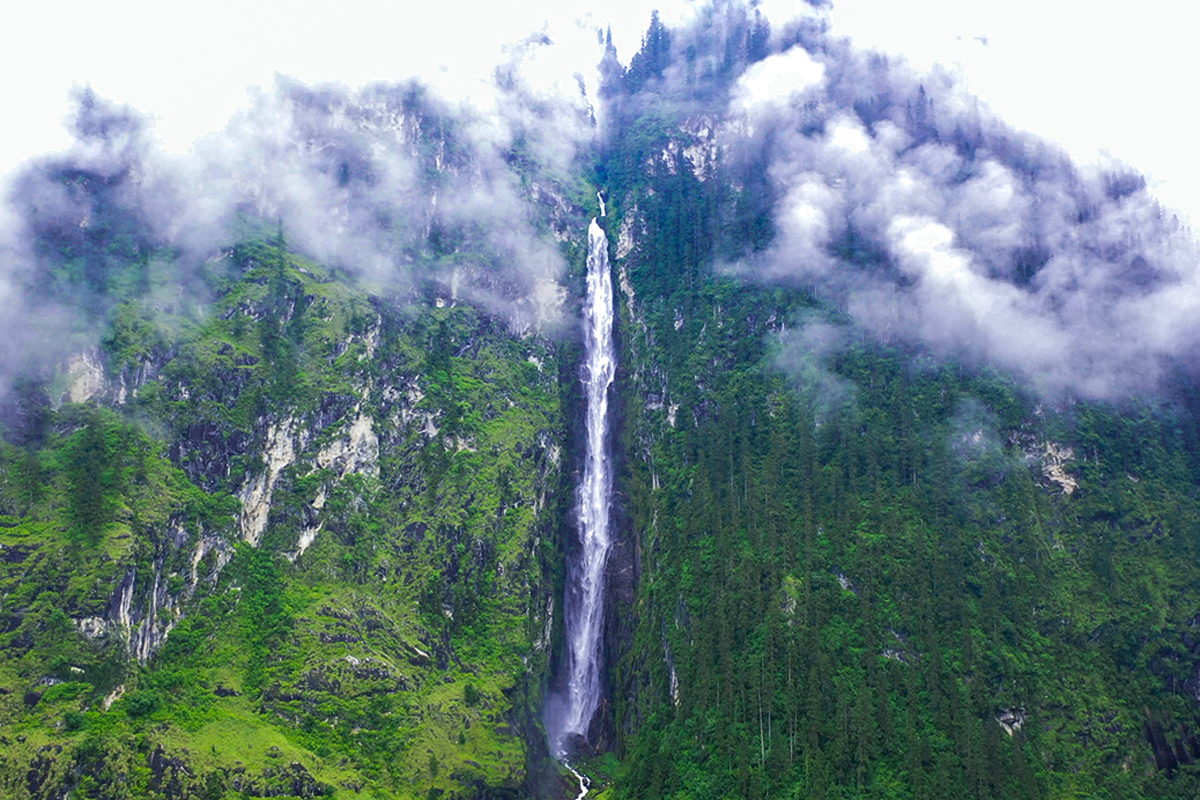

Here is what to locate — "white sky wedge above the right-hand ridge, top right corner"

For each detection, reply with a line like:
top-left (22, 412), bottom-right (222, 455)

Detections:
top-left (830, 0), bottom-right (1200, 225)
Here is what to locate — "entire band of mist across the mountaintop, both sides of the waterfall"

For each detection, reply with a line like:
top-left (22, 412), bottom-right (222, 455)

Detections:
top-left (9, 2), bottom-right (1200, 402)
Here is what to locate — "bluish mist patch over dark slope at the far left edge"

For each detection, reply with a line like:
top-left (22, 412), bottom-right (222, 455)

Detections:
top-left (0, 89), bottom-right (168, 397)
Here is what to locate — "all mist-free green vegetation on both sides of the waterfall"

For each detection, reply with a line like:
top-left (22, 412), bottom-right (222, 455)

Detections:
top-left (0, 12), bottom-right (1200, 800)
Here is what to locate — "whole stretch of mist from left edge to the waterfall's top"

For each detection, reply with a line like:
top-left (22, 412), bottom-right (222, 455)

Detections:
top-left (0, 53), bottom-right (594, 391)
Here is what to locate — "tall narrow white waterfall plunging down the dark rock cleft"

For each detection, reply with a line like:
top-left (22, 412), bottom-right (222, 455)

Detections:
top-left (551, 208), bottom-right (617, 754)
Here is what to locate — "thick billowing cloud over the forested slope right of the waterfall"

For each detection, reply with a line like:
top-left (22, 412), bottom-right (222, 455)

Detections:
top-left (721, 30), bottom-right (1200, 398)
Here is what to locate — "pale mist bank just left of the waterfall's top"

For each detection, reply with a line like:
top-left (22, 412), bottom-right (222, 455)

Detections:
top-left (176, 77), bottom-right (586, 327)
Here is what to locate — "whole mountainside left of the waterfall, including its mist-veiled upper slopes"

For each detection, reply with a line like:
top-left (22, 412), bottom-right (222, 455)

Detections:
top-left (0, 76), bottom-right (595, 798)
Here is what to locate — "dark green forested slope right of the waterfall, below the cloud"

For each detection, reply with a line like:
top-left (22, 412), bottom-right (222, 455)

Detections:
top-left (602, 67), bottom-right (1200, 799)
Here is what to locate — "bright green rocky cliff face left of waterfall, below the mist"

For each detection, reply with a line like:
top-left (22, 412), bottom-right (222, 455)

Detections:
top-left (0, 227), bottom-right (583, 798)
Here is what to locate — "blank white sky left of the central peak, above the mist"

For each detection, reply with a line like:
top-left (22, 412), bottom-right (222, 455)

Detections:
top-left (0, 0), bottom-right (688, 185)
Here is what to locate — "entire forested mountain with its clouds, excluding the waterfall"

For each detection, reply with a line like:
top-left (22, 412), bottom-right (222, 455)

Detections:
top-left (0, 2), bottom-right (1200, 800)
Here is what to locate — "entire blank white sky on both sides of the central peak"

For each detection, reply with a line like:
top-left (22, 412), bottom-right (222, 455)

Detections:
top-left (0, 0), bottom-right (1200, 221)
